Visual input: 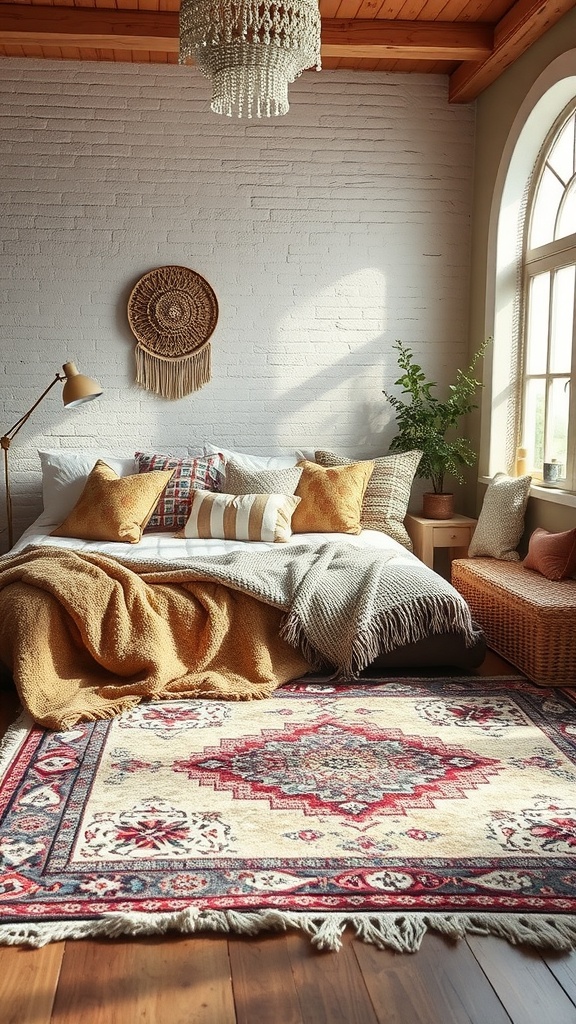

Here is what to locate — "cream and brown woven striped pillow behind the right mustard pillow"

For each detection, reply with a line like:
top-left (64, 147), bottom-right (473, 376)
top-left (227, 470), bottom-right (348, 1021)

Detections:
top-left (316, 452), bottom-right (422, 551)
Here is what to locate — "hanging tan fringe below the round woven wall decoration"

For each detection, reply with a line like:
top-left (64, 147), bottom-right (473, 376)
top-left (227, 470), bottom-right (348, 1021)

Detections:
top-left (136, 344), bottom-right (212, 398)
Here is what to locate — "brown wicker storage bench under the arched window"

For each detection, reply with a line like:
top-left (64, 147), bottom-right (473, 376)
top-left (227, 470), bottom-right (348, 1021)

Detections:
top-left (452, 558), bottom-right (576, 686)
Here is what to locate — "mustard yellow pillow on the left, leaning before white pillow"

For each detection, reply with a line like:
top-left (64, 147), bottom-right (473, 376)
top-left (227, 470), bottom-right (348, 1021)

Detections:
top-left (50, 459), bottom-right (174, 544)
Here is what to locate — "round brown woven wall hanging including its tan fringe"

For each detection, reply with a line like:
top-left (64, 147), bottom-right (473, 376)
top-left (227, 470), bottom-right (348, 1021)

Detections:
top-left (128, 266), bottom-right (218, 398)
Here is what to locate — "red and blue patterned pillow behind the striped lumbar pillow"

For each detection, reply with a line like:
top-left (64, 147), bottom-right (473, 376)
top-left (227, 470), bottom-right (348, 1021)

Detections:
top-left (134, 452), bottom-right (224, 534)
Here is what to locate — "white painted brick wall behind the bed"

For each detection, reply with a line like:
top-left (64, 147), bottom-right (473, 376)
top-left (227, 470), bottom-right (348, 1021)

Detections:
top-left (0, 59), bottom-right (474, 543)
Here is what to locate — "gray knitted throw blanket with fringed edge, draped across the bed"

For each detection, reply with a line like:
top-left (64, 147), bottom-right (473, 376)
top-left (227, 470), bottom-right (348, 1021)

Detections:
top-left (127, 543), bottom-right (478, 681)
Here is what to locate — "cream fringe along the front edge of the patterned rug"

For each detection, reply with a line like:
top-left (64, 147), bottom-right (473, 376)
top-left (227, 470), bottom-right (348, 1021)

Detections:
top-left (0, 908), bottom-right (576, 953)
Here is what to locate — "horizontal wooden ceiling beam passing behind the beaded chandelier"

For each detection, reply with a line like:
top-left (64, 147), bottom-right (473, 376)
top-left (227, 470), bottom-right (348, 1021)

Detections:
top-left (0, 3), bottom-right (493, 61)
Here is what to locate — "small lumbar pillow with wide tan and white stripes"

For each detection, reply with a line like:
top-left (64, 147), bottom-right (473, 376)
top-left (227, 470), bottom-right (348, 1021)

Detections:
top-left (177, 490), bottom-right (300, 544)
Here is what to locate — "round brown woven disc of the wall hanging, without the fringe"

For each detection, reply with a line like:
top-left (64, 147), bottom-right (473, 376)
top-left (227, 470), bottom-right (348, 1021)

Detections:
top-left (128, 266), bottom-right (218, 359)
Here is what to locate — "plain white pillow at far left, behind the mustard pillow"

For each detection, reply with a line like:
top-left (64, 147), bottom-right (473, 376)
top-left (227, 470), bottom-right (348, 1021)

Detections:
top-left (38, 449), bottom-right (138, 526)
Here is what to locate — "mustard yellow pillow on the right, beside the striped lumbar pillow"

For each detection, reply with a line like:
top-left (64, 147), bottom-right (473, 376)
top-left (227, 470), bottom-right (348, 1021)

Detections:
top-left (292, 460), bottom-right (374, 534)
